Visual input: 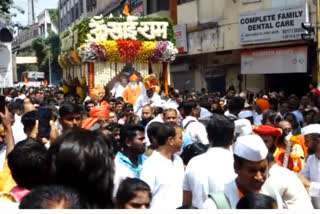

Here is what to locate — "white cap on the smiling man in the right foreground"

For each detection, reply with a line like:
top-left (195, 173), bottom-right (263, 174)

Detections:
top-left (234, 135), bottom-right (268, 162)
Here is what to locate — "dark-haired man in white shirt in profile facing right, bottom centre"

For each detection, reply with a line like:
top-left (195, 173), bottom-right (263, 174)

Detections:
top-left (140, 123), bottom-right (184, 209)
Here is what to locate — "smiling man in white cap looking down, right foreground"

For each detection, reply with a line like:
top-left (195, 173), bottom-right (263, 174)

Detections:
top-left (204, 135), bottom-right (282, 209)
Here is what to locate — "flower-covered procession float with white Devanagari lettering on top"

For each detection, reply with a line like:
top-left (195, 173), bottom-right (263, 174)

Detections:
top-left (59, 15), bottom-right (178, 101)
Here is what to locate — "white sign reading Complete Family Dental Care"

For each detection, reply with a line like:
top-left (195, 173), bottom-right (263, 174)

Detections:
top-left (239, 6), bottom-right (309, 45)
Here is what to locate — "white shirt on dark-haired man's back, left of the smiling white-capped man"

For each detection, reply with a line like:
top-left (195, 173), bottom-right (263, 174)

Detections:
top-left (183, 147), bottom-right (236, 208)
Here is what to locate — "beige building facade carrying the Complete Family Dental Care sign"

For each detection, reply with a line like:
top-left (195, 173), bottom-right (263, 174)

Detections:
top-left (171, 0), bottom-right (316, 94)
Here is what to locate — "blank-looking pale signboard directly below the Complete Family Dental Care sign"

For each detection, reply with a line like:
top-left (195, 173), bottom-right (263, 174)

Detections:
top-left (241, 46), bottom-right (308, 74)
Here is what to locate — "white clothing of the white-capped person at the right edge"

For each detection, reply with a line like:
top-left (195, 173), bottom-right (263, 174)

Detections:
top-left (300, 155), bottom-right (320, 209)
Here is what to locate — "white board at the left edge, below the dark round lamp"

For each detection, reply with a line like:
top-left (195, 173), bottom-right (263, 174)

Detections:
top-left (0, 43), bottom-right (13, 88)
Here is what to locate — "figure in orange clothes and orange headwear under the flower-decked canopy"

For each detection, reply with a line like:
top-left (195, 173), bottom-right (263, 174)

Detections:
top-left (123, 73), bottom-right (142, 106)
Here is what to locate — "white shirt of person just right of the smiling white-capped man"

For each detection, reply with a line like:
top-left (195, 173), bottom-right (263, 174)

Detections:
top-left (266, 164), bottom-right (313, 209)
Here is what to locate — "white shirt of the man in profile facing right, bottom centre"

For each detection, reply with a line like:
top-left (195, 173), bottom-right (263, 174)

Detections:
top-left (140, 151), bottom-right (184, 209)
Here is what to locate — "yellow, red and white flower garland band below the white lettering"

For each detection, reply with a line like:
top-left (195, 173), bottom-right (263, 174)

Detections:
top-left (59, 40), bottom-right (178, 65)
